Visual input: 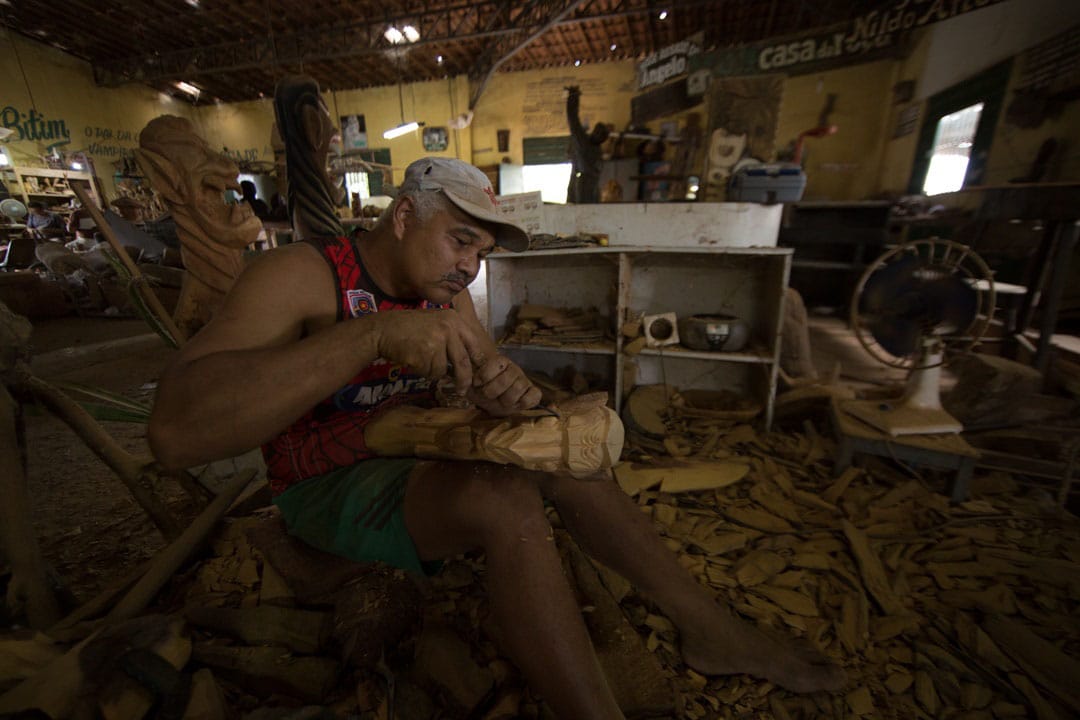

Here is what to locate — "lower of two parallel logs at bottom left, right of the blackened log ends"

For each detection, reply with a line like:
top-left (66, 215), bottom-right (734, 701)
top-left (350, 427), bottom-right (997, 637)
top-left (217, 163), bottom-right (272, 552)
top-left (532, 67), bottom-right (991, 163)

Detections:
top-left (191, 642), bottom-right (340, 703)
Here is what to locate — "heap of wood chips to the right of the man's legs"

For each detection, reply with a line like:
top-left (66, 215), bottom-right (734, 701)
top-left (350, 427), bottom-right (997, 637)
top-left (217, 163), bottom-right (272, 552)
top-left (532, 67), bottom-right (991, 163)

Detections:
top-left (616, 416), bottom-right (1080, 720)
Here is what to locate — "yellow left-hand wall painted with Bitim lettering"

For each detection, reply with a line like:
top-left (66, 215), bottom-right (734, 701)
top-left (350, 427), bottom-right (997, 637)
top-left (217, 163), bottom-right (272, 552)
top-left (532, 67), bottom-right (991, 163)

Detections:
top-left (0, 29), bottom-right (191, 196)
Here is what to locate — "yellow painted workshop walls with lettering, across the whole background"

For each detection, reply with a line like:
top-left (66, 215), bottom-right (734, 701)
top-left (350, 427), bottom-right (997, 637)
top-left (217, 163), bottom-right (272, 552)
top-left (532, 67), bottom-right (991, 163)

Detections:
top-left (0, 0), bottom-right (1080, 208)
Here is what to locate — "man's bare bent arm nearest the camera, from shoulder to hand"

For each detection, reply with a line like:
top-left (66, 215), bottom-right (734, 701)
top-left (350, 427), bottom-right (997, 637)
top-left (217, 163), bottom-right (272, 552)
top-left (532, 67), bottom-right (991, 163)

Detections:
top-left (149, 244), bottom-right (494, 467)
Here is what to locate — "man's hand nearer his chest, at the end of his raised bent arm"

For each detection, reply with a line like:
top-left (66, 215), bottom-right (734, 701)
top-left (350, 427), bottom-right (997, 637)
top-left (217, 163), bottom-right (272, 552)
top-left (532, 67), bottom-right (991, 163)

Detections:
top-left (367, 310), bottom-right (488, 388)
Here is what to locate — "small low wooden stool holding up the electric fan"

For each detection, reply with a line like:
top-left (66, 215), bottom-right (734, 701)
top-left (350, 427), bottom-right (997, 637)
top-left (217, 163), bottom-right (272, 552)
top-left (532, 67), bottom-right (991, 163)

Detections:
top-left (829, 398), bottom-right (978, 503)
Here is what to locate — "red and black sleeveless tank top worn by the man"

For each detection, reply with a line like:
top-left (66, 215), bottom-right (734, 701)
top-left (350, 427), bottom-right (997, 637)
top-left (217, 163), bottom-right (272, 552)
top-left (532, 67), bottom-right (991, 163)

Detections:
top-left (262, 237), bottom-right (448, 495)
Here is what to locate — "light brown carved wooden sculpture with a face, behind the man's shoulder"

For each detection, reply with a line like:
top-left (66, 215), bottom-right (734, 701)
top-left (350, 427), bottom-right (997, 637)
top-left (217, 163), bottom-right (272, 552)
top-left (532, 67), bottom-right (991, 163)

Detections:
top-left (135, 116), bottom-right (262, 337)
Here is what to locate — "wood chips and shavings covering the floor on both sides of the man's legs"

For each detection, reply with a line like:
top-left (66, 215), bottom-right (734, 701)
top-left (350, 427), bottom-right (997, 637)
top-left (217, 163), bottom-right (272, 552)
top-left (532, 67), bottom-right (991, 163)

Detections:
top-left (0, 423), bottom-right (1080, 720)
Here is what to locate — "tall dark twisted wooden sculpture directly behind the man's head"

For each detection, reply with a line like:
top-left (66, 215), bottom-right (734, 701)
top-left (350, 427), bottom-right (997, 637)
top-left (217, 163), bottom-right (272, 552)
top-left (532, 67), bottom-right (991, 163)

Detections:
top-left (273, 76), bottom-right (345, 242)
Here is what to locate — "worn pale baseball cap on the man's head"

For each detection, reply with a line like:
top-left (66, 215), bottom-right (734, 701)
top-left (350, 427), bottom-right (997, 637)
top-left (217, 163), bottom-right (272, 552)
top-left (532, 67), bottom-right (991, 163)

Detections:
top-left (397, 158), bottom-right (529, 253)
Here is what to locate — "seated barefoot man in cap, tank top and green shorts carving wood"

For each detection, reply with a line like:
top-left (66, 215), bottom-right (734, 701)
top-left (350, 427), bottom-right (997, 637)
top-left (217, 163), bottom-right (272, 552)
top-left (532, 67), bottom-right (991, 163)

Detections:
top-left (150, 80), bottom-right (843, 719)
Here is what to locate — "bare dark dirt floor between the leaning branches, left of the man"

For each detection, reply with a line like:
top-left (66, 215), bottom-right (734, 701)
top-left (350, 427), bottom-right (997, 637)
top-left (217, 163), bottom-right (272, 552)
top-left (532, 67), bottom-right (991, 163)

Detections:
top-left (26, 317), bottom-right (186, 601)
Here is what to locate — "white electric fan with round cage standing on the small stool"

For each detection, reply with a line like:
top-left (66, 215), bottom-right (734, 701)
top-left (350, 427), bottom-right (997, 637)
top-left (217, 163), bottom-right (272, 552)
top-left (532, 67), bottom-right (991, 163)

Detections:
top-left (841, 239), bottom-right (995, 436)
